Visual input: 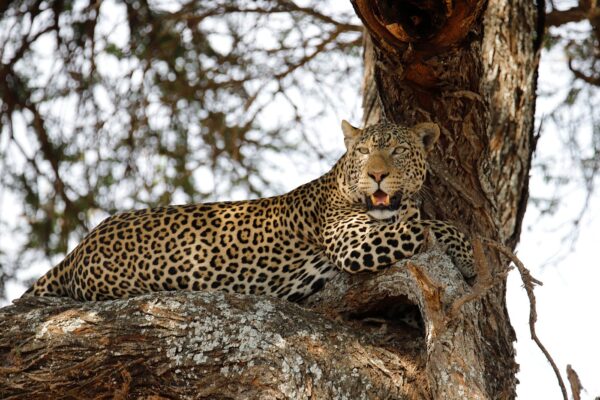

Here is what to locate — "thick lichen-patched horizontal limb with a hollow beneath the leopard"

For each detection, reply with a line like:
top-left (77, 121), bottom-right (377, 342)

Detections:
top-left (0, 248), bottom-right (478, 399)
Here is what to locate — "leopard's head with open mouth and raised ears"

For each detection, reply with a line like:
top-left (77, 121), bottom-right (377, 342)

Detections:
top-left (342, 121), bottom-right (440, 219)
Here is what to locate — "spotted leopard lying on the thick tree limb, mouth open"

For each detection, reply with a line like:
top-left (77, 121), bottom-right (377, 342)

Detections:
top-left (24, 120), bottom-right (475, 302)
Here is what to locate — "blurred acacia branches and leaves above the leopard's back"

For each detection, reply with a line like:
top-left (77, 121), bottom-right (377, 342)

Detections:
top-left (0, 0), bottom-right (362, 291)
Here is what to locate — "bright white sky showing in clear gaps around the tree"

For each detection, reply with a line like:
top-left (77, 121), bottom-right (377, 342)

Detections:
top-left (0, 2), bottom-right (600, 400)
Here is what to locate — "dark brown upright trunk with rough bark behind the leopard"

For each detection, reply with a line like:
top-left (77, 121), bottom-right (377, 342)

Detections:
top-left (352, 0), bottom-right (543, 399)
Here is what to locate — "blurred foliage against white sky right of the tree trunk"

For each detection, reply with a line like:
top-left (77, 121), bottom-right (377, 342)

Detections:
top-left (532, 1), bottom-right (600, 228)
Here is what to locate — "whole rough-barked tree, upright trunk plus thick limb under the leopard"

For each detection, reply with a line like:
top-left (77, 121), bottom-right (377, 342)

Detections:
top-left (0, 0), bottom-right (538, 399)
